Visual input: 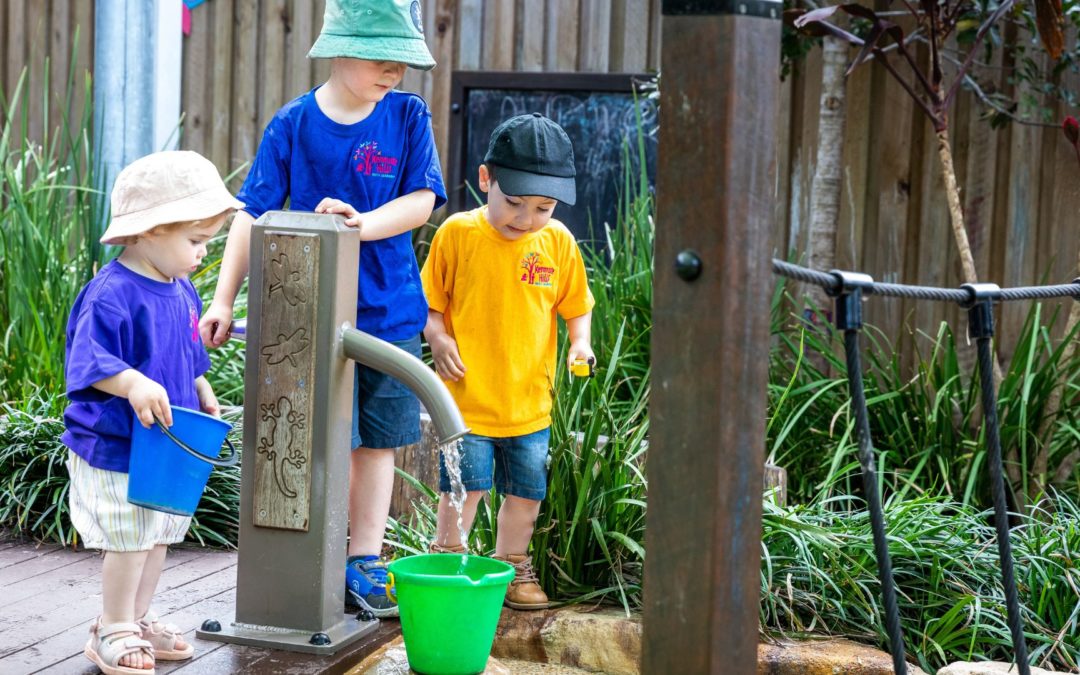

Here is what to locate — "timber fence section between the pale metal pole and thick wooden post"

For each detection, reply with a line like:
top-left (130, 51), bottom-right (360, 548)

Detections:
top-left (172, 0), bottom-right (660, 184)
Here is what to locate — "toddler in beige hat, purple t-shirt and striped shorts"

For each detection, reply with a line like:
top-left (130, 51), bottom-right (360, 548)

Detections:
top-left (63, 151), bottom-right (243, 675)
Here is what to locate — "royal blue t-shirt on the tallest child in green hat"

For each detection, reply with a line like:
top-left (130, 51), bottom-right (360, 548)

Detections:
top-left (237, 87), bottom-right (446, 340)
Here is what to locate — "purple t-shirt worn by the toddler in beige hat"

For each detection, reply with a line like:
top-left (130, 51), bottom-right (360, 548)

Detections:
top-left (62, 260), bottom-right (210, 473)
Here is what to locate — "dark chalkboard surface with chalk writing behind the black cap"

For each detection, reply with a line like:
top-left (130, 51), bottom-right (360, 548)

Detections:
top-left (462, 89), bottom-right (658, 247)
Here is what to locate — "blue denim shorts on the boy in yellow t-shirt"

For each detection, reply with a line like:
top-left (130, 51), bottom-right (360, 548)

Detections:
top-left (438, 428), bottom-right (551, 501)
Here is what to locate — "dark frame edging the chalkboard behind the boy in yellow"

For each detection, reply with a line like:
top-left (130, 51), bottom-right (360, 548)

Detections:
top-left (446, 70), bottom-right (656, 222)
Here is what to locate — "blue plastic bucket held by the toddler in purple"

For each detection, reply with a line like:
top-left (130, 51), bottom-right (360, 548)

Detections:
top-left (127, 406), bottom-right (239, 515)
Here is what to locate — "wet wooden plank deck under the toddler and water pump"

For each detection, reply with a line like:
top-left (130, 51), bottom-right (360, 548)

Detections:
top-left (0, 540), bottom-right (401, 675)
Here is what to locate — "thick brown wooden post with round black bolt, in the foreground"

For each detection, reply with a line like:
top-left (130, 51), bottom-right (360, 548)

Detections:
top-left (642, 0), bottom-right (781, 675)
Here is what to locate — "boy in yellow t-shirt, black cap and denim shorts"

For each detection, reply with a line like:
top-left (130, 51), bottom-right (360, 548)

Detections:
top-left (420, 113), bottom-right (595, 609)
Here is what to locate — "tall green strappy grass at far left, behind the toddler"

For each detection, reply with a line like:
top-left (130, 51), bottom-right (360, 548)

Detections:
top-left (0, 56), bottom-right (100, 401)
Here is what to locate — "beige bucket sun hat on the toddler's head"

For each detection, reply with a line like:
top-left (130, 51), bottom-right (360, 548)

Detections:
top-left (102, 150), bottom-right (244, 244)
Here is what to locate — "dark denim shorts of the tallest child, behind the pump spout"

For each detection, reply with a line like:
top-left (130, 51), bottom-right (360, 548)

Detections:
top-left (352, 335), bottom-right (420, 448)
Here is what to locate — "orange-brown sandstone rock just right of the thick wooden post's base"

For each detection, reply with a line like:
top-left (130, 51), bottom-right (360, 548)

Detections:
top-left (757, 639), bottom-right (926, 675)
